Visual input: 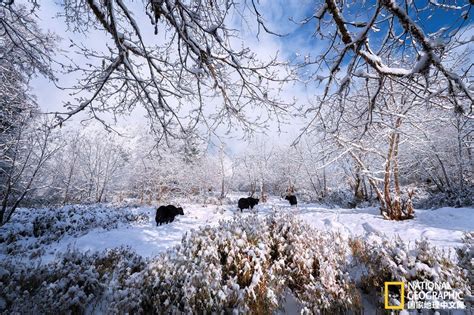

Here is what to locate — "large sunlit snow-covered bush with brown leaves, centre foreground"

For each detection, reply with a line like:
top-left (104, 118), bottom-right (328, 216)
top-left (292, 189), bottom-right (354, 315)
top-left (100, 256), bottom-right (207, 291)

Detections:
top-left (144, 215), bottom-right (359, 313)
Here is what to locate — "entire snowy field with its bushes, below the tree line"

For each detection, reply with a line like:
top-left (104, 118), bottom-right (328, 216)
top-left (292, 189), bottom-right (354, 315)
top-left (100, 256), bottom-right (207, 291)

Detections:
top-left (0, 196), bottom-right (474, 314)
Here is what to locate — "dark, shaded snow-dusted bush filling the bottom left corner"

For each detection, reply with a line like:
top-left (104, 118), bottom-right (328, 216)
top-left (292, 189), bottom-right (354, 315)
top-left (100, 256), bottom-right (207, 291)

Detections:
top-left (0, 248), bottom-right (146, 314)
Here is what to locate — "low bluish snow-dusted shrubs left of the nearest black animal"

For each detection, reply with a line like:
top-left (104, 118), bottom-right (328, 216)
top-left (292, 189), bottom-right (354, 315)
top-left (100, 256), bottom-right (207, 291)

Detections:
top-left (0, 204), bottom-right (149, 255)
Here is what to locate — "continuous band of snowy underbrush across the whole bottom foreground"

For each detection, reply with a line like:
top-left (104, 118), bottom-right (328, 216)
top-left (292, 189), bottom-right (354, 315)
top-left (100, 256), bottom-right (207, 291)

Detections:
top-left (0, 214), bottom-right (472, 314)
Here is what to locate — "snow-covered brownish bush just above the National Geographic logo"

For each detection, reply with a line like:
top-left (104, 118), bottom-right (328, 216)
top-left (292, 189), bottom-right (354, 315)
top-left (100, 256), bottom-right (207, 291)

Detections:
top-left (349, 235), bottom-right (470, 306)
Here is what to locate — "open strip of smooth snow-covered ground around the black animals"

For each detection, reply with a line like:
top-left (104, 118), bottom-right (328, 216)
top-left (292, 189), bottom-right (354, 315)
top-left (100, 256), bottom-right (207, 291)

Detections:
top-left (11, 197), bottom-right (474, 262)
